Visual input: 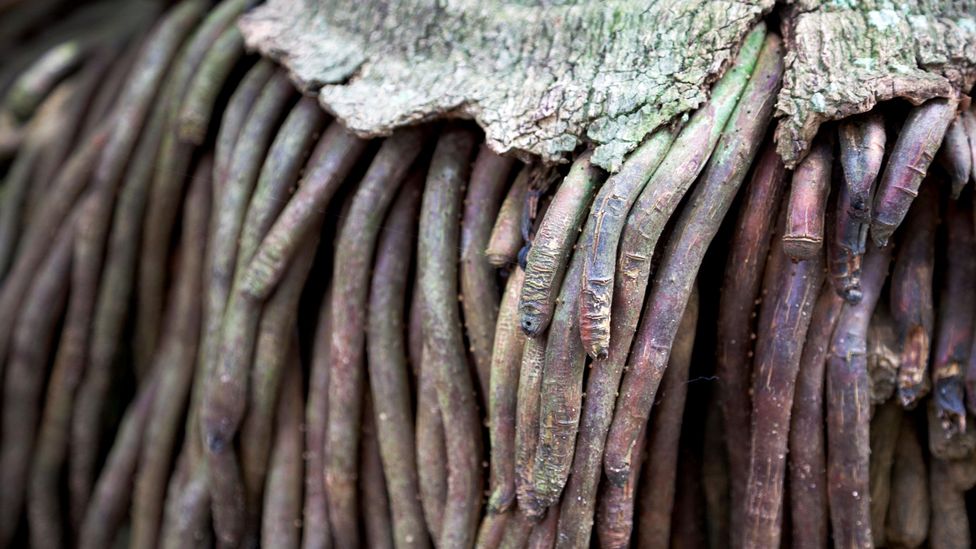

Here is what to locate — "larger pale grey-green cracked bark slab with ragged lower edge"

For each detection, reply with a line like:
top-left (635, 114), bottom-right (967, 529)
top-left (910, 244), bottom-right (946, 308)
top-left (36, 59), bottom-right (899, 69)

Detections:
top-left (240, 0), bottom-right (774, 171)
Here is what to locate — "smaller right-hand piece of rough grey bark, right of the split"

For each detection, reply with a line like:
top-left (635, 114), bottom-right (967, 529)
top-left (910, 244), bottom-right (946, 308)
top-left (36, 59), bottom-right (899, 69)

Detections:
top-left (776, 0), bottom-right (976, 167)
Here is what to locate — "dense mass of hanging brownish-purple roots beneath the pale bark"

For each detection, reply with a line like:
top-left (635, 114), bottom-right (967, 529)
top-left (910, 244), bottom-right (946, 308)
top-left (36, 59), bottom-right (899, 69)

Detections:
top-left (0, 0), bottom-right (976, 548)
